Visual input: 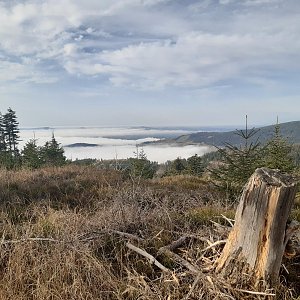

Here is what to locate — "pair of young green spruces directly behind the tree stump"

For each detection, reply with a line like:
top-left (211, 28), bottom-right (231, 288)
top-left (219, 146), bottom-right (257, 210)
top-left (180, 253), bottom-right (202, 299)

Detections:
top-left (210, 119), bottom-right (299, 198)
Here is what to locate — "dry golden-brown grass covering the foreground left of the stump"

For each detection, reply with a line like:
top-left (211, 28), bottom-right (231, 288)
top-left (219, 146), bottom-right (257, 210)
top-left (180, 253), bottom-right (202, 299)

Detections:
top-left (0, 166), bottom-right (299, 300)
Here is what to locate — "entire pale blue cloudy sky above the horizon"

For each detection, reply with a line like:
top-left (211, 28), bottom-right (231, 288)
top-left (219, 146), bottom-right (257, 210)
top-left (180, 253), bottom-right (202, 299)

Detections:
top-left (0, 0), bottom-right (300, 127)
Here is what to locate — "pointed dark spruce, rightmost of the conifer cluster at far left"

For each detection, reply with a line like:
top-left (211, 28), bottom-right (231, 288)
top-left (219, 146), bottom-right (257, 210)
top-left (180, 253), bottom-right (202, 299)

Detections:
top-left (40, 134), bottom-right (66, 166)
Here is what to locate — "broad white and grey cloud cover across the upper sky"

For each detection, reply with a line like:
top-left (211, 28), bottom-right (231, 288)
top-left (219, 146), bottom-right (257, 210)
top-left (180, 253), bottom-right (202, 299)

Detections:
top-left (0, 0), bottom-right (300, 89)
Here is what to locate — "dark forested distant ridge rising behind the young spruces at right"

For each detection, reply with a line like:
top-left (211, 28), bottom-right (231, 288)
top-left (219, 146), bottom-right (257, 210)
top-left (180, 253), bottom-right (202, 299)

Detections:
top-left (169, 121), bottom-right (300, 146)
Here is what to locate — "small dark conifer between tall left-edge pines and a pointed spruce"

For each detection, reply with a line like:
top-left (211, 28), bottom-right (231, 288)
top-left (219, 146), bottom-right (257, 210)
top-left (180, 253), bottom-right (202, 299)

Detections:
top-left (22, 139), bottom-right (42, 169)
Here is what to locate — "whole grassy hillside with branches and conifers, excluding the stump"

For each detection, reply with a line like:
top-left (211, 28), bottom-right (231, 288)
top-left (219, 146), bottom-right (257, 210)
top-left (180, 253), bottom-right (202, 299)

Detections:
top-left (0, 109), bottom-right (300, 300)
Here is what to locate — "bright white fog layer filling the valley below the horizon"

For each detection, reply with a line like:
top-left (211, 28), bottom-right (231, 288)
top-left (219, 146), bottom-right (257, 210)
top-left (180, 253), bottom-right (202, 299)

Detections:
top-left (20, 127), bottom-right (213, 163)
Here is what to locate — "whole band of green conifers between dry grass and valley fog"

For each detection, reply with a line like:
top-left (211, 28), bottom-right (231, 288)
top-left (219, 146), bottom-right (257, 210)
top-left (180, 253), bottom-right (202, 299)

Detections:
top-left (0, 108), bottom-right (300, 198)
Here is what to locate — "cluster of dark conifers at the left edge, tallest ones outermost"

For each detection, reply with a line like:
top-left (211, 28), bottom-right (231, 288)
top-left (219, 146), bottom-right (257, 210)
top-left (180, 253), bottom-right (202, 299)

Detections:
top-left (0, 108), bottom-right (66, 169)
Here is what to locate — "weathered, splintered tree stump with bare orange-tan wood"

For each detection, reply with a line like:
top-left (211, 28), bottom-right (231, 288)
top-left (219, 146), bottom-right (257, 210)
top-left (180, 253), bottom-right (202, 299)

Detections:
top-left (216, 168), bottom-right (296, 287)
